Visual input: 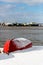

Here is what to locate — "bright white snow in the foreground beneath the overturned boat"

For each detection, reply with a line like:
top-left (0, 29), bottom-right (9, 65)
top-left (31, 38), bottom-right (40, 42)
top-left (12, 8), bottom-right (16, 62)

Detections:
top-left (0, 46), bottom-right (43, 65)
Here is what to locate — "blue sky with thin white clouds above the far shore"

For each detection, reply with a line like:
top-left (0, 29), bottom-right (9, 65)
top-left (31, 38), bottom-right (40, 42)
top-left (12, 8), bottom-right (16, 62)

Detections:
top-left (0, 0), bottom-right (43, 23)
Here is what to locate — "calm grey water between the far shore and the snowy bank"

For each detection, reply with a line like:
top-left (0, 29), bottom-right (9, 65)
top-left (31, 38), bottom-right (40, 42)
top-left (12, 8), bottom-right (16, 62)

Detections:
top-left (0, 28), bottom-right (43, 47)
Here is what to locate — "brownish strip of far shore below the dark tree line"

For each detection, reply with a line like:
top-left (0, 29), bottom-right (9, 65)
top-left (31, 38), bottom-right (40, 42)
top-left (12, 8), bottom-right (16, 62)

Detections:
top-left (0, 26), bottom-right (43, 30)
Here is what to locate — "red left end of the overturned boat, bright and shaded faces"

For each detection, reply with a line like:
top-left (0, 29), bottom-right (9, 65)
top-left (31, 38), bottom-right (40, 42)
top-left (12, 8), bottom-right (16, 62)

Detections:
top-left (3, 40), bottom-right (17, 53)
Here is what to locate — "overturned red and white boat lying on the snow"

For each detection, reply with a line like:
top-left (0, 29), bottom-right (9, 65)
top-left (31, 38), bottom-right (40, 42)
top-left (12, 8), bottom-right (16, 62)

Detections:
top-left (3, 38), bottom-right (32, 53)
